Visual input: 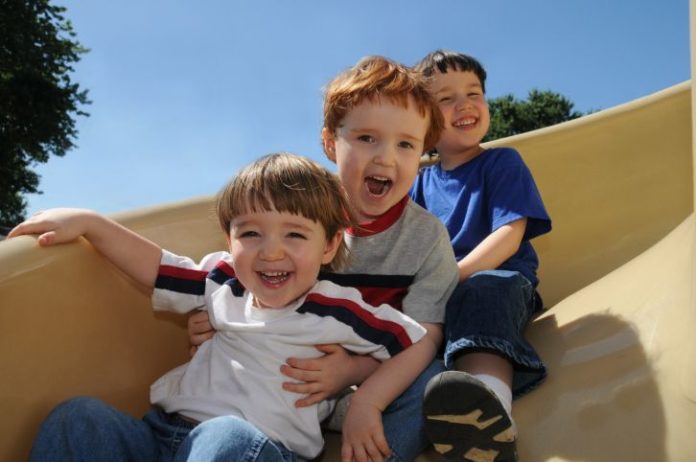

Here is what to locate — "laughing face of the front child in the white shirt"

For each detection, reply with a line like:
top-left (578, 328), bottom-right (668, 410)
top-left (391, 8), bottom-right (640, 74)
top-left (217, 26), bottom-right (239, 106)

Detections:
top-left (229, 211), bottom-right (343, 308)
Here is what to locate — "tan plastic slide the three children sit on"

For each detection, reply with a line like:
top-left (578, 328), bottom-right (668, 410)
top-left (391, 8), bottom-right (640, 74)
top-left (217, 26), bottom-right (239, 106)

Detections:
top-left (0, 28), bottom-right (696, 462)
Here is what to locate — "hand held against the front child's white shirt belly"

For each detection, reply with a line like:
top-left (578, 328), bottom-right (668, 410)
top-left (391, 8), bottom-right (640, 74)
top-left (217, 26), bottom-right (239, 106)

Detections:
top-left (280, 344), bottom-right (355, 407)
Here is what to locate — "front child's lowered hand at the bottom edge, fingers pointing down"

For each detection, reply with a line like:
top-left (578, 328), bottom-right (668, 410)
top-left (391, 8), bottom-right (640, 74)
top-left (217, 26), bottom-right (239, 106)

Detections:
top-left (341, 396), bottom-right (391, 462)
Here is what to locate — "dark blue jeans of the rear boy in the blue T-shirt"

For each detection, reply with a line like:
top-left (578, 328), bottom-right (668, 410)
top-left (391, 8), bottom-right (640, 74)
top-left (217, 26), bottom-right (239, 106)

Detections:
top-left (444, 270), bottom-right (546, 398)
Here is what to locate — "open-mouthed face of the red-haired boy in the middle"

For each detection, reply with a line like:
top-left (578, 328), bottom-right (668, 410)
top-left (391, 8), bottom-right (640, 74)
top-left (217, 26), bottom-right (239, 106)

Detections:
top-left (322, 98), bottom-right (429, 224)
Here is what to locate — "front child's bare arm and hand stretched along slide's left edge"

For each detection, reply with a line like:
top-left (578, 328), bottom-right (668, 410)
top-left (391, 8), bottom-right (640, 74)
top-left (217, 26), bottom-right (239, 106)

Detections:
top-left (8, 209), bottom-right (162, 288)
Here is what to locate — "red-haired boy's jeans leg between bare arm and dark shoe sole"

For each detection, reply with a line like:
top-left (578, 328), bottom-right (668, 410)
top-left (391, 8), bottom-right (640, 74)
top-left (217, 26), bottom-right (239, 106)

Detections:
top-left (382, 360), bottom-right (445, 462)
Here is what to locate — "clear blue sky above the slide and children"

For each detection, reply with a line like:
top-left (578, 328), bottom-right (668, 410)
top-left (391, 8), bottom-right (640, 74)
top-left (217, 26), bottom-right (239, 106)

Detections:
top-left (28, 0), bottom-right (690, 217)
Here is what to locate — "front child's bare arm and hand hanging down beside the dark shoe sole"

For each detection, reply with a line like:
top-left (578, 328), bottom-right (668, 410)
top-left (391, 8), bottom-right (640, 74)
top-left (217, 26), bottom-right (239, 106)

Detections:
top-left (341, 324), bottom-right (442, 462)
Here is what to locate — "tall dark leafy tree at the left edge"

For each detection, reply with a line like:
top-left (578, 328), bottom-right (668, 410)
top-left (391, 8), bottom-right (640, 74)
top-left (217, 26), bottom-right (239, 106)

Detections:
top-left (0, 0), bottom-right (90, 226)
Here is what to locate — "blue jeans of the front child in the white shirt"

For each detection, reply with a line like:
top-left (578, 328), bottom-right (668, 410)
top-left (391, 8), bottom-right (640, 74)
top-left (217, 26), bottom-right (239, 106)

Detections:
top-left (29, 398), bottom-right (298, 462)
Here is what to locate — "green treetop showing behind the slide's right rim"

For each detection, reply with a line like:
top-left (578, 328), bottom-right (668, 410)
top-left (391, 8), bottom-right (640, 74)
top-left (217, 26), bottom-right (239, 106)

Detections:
top-left (484, 89), bottom-right (584, 141)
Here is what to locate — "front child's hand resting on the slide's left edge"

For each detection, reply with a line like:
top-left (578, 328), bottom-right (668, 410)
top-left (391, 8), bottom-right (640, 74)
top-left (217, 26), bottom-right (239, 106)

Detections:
top-left (7, 209), bottom-right (94, 246)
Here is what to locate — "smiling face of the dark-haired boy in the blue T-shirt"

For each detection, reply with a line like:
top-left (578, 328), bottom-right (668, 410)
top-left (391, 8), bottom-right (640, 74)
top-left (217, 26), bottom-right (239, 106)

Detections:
top-left (429, 69), bottom-right (491, 170)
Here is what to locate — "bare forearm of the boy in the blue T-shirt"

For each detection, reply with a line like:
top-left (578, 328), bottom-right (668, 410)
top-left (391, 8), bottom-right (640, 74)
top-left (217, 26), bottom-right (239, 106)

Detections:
top-left (457, 218), bottom-right (527, 281)
